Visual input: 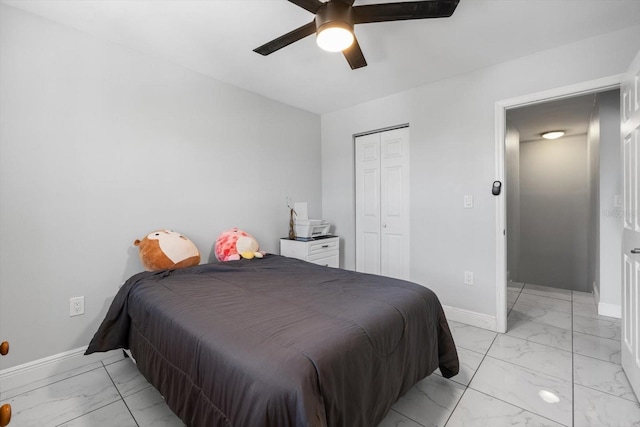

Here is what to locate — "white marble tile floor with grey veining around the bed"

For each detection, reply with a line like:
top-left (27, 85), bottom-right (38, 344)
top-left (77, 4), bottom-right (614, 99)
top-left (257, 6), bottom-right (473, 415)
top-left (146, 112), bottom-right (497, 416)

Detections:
top-left (0, 283), bottom-right (640, 427)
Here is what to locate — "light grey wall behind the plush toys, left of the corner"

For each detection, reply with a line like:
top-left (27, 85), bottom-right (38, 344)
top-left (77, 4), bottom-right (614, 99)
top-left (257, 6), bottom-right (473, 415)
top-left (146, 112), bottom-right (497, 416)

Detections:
top-left (0, 5), bottom-right (322, 368)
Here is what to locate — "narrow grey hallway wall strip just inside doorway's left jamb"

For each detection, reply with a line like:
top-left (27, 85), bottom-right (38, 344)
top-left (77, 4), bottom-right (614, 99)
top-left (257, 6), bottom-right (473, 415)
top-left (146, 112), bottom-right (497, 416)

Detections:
top-left (505, 122), bottom-right (520, 282)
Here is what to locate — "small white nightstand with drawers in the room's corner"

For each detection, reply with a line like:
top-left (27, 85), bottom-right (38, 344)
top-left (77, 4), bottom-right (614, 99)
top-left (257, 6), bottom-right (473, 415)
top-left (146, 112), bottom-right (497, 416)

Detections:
top-left (280, 236), bottom-right (340, 268)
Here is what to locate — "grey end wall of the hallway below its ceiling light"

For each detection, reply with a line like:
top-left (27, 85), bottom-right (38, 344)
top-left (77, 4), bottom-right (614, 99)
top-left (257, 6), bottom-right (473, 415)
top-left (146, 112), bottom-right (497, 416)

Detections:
top-left (518, 135), bottom-right (589, 291)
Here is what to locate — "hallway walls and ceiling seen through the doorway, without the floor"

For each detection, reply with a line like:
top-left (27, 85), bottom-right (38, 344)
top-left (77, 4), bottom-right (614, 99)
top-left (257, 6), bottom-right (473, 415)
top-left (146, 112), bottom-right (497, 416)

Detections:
top-left (505, 89), bottom-right (621, 294)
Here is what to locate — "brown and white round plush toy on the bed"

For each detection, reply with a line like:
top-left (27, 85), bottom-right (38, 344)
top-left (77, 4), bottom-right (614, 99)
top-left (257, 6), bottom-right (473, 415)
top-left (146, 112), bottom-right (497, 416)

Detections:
top-left (133, 230), bottom-right (200, 271)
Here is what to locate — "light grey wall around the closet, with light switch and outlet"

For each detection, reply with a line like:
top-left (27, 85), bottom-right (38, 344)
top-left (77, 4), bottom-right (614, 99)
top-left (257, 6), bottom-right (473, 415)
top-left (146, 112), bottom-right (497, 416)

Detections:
top-left (322, 26), bottom-right (640, 324)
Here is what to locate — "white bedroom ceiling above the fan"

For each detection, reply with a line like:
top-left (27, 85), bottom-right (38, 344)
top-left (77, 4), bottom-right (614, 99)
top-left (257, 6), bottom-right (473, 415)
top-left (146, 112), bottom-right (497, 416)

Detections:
top-left (1, 0), bottom-right (640, 113)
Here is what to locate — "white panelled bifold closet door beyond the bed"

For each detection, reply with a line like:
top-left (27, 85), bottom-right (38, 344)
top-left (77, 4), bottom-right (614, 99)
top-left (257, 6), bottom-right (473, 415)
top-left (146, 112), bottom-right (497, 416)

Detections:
top-left (355, 128), bottom-right (410, 279)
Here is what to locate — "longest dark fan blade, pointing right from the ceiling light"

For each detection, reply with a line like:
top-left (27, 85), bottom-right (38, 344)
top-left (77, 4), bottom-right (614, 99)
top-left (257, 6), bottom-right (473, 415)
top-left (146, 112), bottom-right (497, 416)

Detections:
top-left (353, 0), bottom-right (460, 24)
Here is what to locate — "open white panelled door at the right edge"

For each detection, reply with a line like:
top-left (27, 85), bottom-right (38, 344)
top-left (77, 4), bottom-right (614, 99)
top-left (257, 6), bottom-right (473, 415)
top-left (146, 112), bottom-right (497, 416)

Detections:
top-left (620, 52), bottom-right (640, 402)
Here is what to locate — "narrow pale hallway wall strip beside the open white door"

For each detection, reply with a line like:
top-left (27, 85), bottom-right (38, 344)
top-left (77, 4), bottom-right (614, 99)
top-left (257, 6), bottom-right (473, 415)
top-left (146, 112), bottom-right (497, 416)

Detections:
top-left (596, 91), bottom-right (622, 317)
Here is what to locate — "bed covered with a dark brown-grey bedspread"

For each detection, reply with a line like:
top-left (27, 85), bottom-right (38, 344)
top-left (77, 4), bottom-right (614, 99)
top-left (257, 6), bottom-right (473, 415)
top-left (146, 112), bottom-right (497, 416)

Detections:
top-left (86, 255), bottom-right (458, 427)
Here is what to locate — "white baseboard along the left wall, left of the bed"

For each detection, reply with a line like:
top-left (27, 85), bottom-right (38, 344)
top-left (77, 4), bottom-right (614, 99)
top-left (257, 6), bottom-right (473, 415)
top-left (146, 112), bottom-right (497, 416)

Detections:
top-left (0, 347), bottom-right (122, 393)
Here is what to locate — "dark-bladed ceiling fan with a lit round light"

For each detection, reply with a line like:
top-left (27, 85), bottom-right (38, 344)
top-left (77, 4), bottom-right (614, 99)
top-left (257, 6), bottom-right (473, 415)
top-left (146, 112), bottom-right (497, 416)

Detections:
top-left (253, 0), bottom-right (460, 70)
